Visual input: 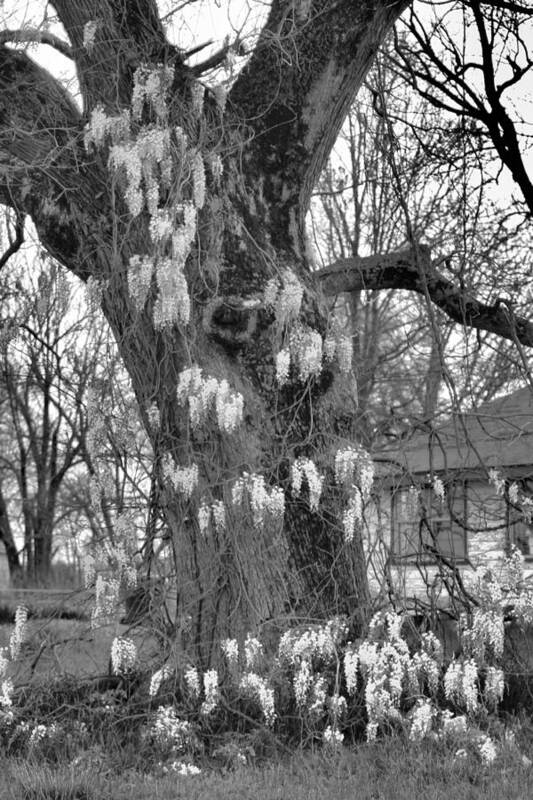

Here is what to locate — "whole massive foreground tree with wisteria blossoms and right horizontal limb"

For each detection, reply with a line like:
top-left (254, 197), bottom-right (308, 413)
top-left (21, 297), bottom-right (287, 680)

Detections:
top-left (0, 0), bottom-right (533, 662)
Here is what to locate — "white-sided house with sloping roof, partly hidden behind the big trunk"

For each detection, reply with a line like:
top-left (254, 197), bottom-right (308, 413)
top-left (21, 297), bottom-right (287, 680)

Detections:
top-left (365, 388), bottom-right (533, 605)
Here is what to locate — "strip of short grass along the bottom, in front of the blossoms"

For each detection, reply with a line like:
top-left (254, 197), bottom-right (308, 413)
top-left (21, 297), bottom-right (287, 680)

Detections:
top-left (0, 739), bottom-right (533, 800)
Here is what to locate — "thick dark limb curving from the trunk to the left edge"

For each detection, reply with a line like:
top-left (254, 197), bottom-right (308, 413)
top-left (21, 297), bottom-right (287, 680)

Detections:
top-left (0, 45), bottom-right (110, 277)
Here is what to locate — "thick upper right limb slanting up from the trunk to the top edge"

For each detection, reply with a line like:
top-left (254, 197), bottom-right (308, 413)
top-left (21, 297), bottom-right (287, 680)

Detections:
top-left (229, 0), bottom-right (407, 229)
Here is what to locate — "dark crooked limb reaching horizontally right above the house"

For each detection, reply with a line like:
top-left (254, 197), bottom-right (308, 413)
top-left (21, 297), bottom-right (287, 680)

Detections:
top-left (316, 245), bottom-right (533, 347)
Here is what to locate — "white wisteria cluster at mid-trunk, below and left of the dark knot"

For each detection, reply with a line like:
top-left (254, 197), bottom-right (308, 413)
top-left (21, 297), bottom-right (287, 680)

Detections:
top-left (177, 365), bottom-right (244, 433)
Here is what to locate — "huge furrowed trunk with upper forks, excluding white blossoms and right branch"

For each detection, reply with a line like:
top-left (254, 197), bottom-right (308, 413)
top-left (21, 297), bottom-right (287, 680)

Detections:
top-left (0, 0), bottom-right (405, 662)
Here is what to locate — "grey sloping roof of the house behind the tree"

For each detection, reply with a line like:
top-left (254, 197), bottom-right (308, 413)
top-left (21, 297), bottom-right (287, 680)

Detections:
top-left (379, 387), bottom-right (533, 474)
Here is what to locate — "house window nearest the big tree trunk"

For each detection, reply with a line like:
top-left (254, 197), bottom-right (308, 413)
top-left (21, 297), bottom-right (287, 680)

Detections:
top-left (392, 481), bottom-right (467, 563)
